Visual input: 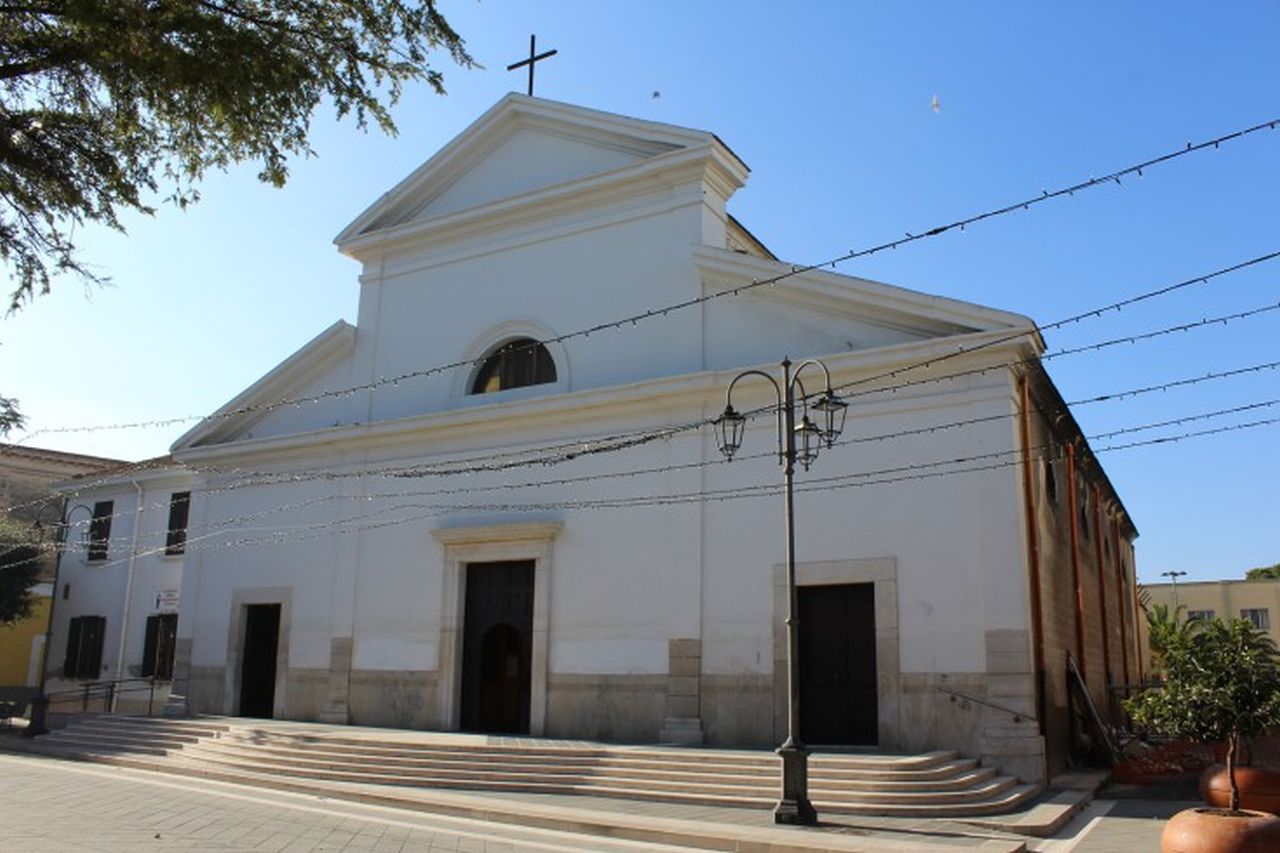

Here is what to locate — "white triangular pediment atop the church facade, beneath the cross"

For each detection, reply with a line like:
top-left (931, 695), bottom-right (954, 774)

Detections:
top-left (334, 93), bottom-right (746, 247)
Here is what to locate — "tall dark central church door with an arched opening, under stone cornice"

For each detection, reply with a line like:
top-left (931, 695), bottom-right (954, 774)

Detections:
top-left (461, 560), bottom-right (534, 734)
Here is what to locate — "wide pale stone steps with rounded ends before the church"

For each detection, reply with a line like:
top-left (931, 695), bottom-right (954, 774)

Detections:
top-left (15, 716), bottom-right (1041, 817)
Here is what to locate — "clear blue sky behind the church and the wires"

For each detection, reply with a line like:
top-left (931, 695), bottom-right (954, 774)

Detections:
top-left (0, 0), bottom-right (1280, 581)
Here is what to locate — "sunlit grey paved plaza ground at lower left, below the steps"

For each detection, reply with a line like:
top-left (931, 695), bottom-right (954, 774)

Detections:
top-left (0, 756), bottom-right (672, 853)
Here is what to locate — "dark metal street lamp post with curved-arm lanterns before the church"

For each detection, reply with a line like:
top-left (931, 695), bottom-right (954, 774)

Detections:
top-left (717, 359), bottom-right (849, 825)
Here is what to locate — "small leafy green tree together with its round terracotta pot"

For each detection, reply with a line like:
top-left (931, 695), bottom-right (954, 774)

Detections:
top-left (1125, 619), bottom-right (1280, 853)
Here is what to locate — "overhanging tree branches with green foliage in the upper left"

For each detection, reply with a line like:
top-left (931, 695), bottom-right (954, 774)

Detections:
top-left (0, 0), bottom-right (474, 311)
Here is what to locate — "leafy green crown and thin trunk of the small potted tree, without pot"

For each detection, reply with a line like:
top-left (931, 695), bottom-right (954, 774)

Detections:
top-left (1124, 619), bottom-right (1280, 809)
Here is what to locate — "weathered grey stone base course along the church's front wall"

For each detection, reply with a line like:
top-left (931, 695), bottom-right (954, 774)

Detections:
top-left (182, 630), bottom-right (1047, 783)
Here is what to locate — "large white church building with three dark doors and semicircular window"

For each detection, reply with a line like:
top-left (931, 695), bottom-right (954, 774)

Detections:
top-left (51, 95), bottom-right (1142, 781)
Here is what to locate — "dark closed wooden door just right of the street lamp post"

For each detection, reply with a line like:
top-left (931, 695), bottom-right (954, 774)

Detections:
top-left (796, 584), bottom-right (879, 745)
